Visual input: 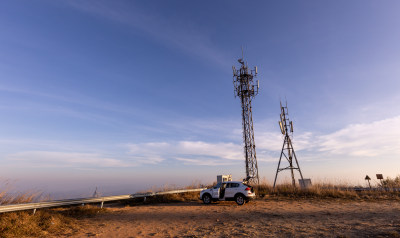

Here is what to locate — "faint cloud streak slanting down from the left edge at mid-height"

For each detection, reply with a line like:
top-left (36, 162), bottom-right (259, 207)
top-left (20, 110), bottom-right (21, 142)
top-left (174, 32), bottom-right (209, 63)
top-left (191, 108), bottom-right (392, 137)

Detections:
top-left (0, 84), bottom-right (174, 132)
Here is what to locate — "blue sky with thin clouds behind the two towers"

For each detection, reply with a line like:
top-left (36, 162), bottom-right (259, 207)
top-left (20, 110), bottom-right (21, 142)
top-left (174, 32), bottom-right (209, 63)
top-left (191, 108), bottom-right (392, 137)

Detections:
top-left (0, 0), bottom-right (400, 196)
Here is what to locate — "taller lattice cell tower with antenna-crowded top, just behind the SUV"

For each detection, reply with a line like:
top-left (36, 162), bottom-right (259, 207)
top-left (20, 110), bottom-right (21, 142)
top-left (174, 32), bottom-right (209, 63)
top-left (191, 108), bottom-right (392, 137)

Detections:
top-left (232, 51), bottom-right (260, 184)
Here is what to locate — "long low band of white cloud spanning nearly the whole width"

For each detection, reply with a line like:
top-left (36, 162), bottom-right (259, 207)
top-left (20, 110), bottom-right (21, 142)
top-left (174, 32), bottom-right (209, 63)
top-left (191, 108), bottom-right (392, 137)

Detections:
top-left (5, 116), bottom-right (400, 168)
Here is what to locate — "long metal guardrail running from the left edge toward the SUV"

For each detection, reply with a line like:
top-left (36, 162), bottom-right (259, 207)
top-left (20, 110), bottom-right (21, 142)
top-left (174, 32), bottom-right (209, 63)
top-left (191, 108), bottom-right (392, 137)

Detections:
top-left (0, 188), bottom-right (204, 213)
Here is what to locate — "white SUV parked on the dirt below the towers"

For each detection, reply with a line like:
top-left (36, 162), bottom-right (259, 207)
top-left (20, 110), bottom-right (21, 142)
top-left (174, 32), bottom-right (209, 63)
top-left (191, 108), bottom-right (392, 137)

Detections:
top-left (200, 181), bottom-right (256, 205)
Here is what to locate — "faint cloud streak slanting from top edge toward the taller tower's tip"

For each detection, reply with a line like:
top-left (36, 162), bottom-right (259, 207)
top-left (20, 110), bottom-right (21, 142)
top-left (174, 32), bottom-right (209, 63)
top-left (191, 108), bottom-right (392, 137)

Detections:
top-left (68, 1), bottom-right (231, 70)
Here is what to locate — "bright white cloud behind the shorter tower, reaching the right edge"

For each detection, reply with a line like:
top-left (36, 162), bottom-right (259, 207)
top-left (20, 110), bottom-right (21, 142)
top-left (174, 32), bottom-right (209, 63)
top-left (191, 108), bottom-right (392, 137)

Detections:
top-left (256, 116), bottom-right (400, 164)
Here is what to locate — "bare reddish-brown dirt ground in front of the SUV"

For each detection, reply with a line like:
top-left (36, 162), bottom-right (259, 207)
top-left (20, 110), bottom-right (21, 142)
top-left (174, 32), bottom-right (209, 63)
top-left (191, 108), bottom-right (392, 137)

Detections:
top-left (55, 199), bottom-right (400, 237)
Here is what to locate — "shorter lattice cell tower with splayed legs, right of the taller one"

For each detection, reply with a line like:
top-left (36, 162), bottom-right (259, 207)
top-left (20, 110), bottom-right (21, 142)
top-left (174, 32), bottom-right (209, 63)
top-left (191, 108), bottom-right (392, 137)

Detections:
top-left (274, 102), bottom-right (303, 188)
